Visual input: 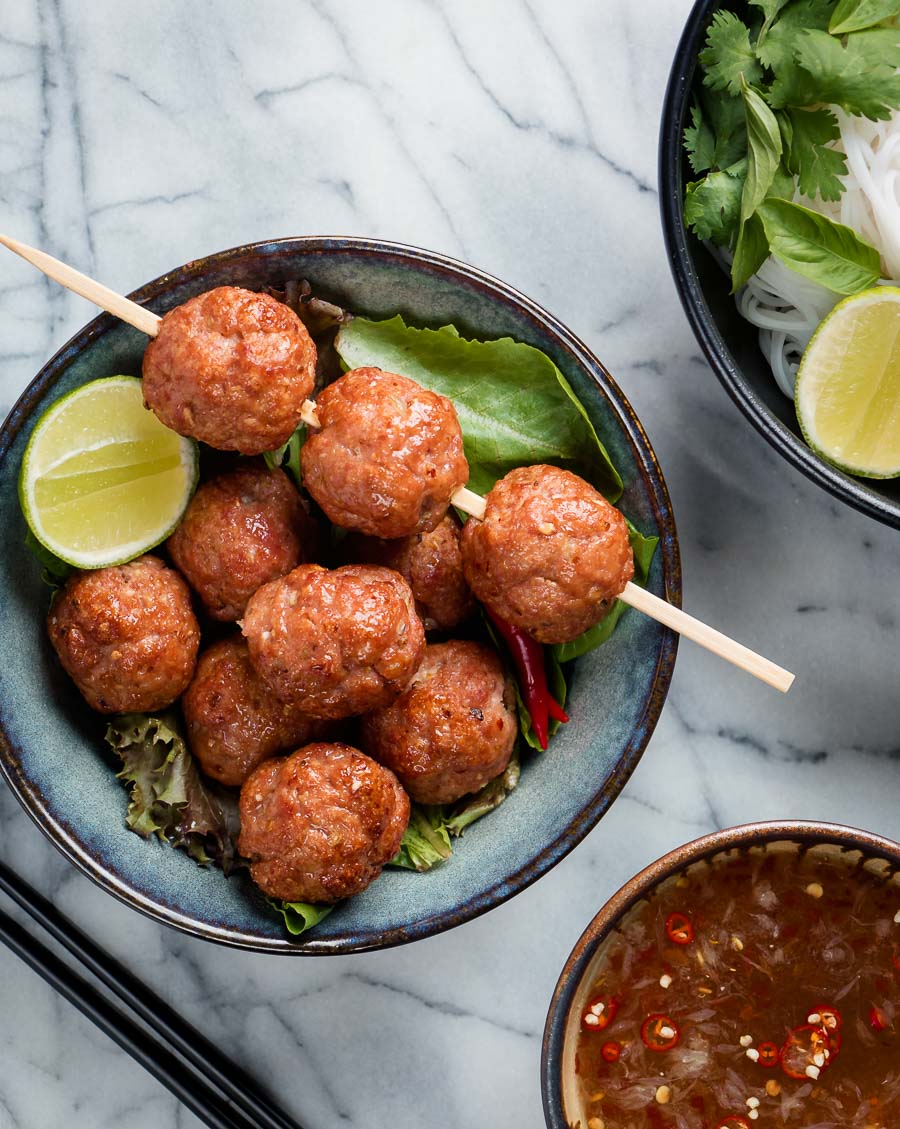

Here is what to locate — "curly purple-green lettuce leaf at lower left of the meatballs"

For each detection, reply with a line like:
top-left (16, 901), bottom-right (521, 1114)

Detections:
top-left (106, 711), bottom-right (238, 874)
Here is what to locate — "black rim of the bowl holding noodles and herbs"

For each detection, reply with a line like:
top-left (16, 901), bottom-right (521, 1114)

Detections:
top-left (658, 0), bottom-right (900, 528)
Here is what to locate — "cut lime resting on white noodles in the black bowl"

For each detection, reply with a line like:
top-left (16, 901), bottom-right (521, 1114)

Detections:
top-left (795, 286), bottom-right (900, 479)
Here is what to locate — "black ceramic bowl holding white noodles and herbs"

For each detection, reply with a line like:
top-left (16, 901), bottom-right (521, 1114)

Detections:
top-left (659, 0), bottom-right (900, 528)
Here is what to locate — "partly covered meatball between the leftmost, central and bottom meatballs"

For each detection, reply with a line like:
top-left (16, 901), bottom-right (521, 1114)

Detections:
top-left (182, 637), bottom-right (325, 785)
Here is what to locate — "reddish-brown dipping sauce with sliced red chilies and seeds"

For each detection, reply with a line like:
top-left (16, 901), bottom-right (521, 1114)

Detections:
top-left (573, 843), bottom-right (900, 1129)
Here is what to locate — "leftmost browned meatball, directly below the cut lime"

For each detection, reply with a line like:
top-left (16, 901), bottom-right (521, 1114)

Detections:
top-left (47, 557), bottom-right (200, 714)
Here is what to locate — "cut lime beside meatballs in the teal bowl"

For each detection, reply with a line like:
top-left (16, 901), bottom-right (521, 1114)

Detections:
top-left (19, 376), bottom-right (198, 568)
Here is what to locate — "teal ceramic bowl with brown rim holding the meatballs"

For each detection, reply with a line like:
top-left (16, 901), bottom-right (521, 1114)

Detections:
top-left (0, 237), bottom-right (681, 954)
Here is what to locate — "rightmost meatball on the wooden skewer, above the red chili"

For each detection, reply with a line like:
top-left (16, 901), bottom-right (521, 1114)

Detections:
top-left (461, 466), bottom-right (635, 642)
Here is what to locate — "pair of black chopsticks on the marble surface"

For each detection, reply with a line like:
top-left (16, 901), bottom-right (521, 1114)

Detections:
top-left (0, 863), bottom-right (302, 1129)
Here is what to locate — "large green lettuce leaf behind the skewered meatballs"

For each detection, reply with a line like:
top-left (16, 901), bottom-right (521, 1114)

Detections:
top-left (335, 316), bottom-right (622, 501)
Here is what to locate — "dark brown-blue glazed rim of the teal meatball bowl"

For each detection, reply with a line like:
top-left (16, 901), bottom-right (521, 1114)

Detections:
top-left (0, 236), bottom-right (682, 955)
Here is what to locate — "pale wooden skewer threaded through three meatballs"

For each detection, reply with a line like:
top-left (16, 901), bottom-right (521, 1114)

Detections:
top-left (0, 235), bottom-right (794, 693)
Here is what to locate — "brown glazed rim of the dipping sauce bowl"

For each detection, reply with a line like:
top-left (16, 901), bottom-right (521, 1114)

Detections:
top-left (541, 820), bottom-right (900, 1129)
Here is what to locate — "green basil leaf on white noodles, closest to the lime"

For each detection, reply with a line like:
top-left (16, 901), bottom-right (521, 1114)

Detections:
top-left (759, 200), bottom-right (881, 294)
